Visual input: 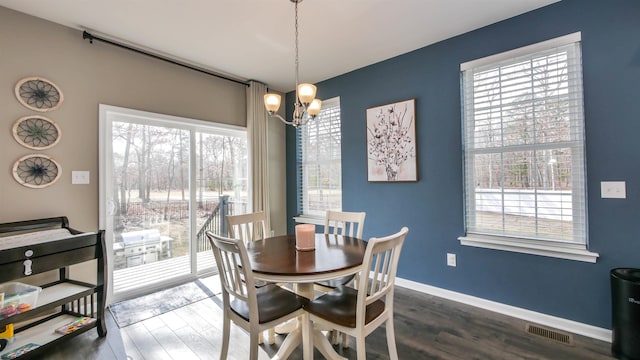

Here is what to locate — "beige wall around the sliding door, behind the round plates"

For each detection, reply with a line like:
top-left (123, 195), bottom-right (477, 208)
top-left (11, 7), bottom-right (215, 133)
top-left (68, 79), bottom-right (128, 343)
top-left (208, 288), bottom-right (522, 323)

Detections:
top-left (0, 7), bottom-right (248, 231)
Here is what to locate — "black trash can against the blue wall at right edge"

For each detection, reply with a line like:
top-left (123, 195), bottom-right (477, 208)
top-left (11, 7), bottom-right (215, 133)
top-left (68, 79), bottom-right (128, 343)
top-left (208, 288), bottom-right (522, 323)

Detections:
top-left (611, 268), bottom-right (640, 360)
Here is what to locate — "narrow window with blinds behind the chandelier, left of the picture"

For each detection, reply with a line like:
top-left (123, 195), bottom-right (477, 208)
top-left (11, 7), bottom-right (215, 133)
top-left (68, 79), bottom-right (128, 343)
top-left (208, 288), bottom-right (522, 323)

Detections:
top-left (297, 97), bottom-right (342, 217)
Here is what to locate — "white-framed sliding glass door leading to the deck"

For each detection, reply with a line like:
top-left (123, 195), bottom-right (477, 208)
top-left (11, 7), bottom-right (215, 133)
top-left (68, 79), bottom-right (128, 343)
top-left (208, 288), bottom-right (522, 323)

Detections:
top-left (100, 105), bottom-right (248, 302)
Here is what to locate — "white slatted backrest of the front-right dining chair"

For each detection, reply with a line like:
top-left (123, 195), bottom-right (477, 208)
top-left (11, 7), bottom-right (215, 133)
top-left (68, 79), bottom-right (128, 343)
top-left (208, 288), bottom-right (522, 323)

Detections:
top-left (356, 226), bottom-right (409, 325)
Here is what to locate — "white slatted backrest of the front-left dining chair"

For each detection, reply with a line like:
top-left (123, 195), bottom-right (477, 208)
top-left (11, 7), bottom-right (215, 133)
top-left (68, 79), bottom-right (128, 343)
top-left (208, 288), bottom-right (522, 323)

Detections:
top-left (206, 231), bottom-right (258, 314)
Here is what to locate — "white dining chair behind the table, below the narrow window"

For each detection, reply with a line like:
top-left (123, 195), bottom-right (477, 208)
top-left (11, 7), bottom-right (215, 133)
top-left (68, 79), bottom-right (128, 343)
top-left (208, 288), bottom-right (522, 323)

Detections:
top-left (314, 210), bottom-right (367, 348)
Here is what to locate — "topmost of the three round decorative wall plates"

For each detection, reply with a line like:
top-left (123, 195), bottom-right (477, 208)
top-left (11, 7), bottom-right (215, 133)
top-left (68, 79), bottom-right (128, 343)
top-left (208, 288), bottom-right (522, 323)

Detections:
top-left (15, 77), bottom-right (64, 112)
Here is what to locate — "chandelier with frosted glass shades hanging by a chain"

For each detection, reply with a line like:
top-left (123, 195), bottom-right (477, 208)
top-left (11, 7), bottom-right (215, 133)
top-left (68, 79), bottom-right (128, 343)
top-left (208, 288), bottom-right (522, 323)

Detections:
top-left (264, 0), bottom-right (322, 128)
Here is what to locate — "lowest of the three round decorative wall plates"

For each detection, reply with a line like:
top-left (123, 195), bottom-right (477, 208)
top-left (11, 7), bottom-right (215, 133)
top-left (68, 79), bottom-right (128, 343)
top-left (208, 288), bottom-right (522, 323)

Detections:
top-left (13, 154), bottom-right (62, 189)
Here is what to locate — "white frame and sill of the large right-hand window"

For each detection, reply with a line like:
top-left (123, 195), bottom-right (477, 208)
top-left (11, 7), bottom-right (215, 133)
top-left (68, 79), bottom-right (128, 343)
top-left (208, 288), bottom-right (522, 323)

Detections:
top-left (458, 32), bottom-right (599, 263)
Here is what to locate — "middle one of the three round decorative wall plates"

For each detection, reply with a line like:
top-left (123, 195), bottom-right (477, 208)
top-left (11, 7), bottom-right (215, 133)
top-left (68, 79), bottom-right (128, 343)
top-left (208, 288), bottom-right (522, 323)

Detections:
top-left (13, 115), bottom-right (62, 150)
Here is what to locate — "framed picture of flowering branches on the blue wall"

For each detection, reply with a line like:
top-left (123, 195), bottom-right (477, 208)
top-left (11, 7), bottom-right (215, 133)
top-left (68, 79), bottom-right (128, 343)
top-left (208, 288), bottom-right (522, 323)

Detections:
top-left (366, 99), bottom-right (418, 182)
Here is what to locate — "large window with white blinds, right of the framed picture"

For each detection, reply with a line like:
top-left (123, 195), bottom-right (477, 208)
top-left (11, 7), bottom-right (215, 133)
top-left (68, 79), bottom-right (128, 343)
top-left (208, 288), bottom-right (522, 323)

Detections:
top-left (461, 33), bottom-right (587, 249)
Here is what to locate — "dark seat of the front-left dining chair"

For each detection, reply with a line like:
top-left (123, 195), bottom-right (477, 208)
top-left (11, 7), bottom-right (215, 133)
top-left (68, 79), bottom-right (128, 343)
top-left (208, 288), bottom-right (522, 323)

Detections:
top-left (231, 284), bottom-right (309, 324)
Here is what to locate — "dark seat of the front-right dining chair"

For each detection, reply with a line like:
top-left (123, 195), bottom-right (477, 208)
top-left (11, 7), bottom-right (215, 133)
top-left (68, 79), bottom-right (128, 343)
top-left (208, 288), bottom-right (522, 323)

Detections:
top-left (304, 286), bottom-right (384, 328)
